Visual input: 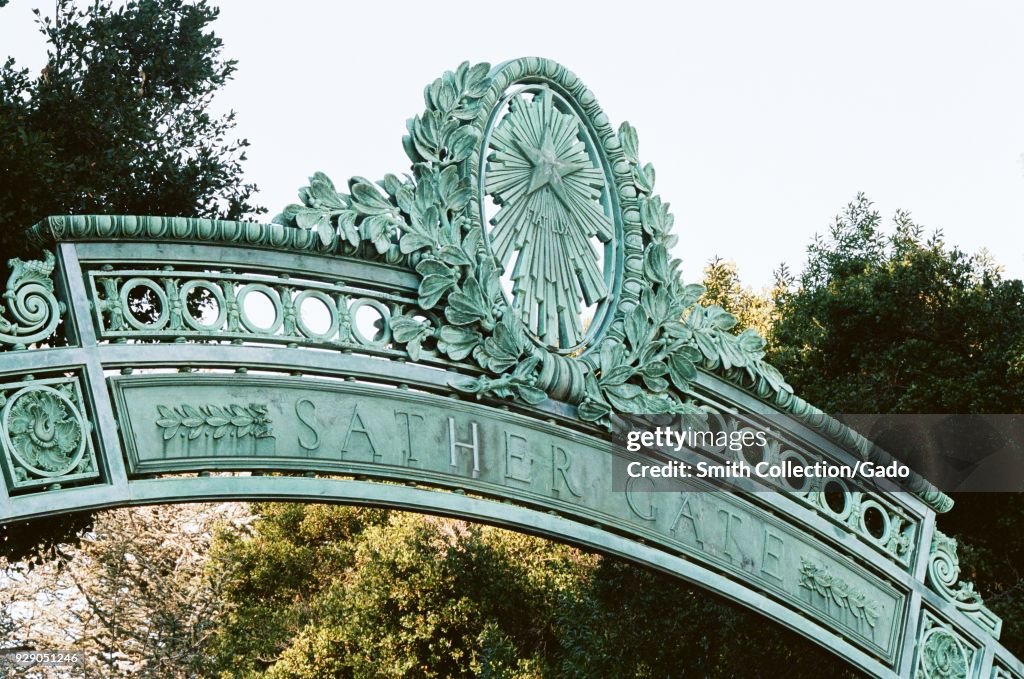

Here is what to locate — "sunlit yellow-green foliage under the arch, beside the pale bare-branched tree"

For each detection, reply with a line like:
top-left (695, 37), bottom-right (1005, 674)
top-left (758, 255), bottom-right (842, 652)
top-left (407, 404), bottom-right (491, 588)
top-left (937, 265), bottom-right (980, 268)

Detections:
top-left (212, 505), bottom-right (586, 677)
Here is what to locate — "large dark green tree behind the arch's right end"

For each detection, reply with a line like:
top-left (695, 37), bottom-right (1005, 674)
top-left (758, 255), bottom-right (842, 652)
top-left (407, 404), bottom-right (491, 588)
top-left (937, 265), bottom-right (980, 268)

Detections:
top-left (768, 195), bottom-right (1024, 654)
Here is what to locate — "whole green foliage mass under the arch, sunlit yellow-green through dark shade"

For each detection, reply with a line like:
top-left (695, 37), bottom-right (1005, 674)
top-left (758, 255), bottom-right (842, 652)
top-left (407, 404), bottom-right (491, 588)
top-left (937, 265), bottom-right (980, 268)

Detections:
top-left (211, 505), bottom-right (856, 679)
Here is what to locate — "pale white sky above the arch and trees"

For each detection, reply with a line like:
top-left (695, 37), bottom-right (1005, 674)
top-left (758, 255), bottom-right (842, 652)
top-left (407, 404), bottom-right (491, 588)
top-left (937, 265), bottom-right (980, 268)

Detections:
top-left (0, 0), bottom-right (1024, 288)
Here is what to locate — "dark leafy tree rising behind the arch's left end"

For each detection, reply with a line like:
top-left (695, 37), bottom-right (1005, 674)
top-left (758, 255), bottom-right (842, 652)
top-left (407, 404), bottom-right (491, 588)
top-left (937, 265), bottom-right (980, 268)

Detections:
top-left (0, 0), bottom-right (262, 259)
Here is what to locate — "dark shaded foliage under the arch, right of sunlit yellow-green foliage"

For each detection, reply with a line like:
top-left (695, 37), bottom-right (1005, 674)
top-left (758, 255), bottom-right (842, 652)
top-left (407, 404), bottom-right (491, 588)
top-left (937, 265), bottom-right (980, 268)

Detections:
top-left (552, 558), bottom-right (860, 679)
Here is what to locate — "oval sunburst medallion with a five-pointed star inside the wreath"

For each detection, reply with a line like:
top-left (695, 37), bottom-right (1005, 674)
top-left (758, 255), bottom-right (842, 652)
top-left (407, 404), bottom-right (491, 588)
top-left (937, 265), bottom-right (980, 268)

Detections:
top-left (479, 82), bottom-right (623, 353)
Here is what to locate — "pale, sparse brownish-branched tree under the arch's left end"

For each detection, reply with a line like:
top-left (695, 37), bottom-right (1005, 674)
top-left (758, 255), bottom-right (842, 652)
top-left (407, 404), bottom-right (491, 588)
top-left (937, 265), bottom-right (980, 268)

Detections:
top-left (0, 504), bottom-right (250, 679)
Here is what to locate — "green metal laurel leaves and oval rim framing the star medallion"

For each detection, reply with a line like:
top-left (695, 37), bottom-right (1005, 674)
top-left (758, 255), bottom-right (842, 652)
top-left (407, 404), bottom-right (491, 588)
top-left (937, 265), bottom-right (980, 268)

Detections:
top-left (275, 59), bottom-right (792, 424)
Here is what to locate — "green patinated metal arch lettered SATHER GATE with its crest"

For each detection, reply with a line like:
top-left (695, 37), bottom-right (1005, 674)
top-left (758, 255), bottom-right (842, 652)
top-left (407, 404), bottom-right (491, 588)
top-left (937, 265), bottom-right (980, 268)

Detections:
top-left (0, 58), bottom-right (1024, 677)
